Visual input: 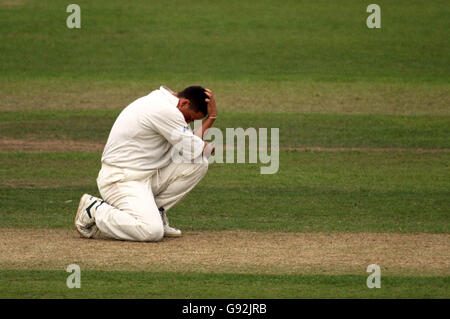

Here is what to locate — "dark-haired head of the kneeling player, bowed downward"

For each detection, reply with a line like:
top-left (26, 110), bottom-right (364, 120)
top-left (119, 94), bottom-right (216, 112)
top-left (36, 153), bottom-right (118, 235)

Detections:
top-left (175, 86), bottom-right (208, 123)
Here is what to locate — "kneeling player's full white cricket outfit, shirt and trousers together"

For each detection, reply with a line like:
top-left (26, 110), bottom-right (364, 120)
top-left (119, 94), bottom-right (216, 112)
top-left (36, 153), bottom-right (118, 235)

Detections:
top-left (95, 87), bottom-right (208, 241)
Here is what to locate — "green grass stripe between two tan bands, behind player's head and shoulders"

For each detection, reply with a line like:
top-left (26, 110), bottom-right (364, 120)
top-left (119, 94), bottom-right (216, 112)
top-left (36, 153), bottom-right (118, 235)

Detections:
top-left (0, 110), bottom-right (450, 149)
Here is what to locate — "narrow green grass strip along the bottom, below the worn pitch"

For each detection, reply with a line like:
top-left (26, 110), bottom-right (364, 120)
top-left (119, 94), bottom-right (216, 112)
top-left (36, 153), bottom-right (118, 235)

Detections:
top-left (0, 270), bottom-right (450, 299)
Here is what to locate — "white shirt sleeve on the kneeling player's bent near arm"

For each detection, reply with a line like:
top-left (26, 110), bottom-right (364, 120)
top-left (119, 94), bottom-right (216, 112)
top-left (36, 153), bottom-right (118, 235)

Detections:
top-left (148, 108), bottom-right (205, 162)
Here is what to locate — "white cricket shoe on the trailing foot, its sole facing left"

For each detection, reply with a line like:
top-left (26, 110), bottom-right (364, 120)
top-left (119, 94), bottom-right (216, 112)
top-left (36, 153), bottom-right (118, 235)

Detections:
top-left (75, 194), bottom-right (102, 238)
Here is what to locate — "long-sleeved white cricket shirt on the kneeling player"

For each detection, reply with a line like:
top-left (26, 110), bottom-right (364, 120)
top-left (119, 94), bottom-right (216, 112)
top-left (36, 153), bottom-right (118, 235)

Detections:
top-left (102, 86), bottom-right (205, 170)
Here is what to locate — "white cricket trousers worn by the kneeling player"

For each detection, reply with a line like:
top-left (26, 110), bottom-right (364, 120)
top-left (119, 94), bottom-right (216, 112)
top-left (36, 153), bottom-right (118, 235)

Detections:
top-left (95, 159), bottom-right (208, 241)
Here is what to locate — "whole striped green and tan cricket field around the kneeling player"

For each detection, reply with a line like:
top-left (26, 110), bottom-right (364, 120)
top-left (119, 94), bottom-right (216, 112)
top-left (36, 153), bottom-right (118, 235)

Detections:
top-left (0, 0), bottom-right (450, 298)
